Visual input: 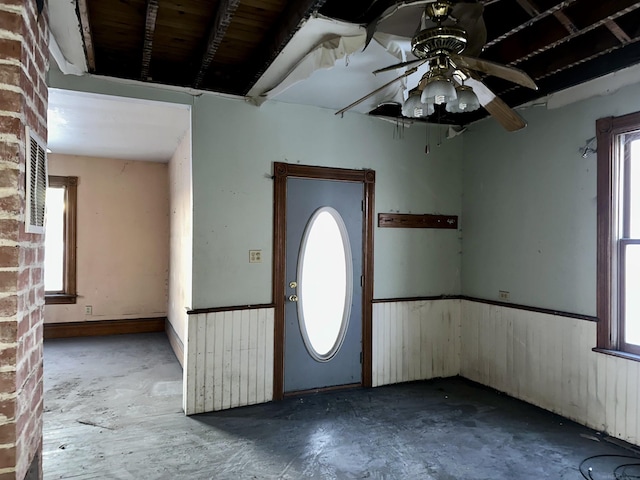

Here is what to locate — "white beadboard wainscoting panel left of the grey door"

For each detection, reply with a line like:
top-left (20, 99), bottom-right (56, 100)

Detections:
top-left (183, 306), bottom-right (274, 415)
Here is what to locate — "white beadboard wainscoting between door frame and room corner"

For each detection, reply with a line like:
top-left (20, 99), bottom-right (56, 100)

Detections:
top-left (372, 298), bottom-right (460, 387)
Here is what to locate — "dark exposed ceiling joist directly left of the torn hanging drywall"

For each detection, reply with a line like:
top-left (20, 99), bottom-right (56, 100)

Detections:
top-left (243, 0), bottom-right (326, 95)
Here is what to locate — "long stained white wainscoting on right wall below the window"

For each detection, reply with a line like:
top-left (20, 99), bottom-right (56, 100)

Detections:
top-left (460, 300), bottom-right (640, 445)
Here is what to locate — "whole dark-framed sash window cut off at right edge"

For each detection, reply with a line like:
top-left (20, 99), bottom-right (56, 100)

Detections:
top-left (596, 113), bottom-right (640, 360)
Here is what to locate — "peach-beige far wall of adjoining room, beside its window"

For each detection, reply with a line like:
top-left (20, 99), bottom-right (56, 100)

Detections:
top-left (45, 154), bottom-right (169, 323)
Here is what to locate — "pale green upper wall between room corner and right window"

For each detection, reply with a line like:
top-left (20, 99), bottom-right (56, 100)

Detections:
top-left (462, 85), bottom-right (640, 315)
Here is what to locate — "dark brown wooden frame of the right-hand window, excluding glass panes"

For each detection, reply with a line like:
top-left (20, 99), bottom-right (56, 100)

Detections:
top-left (594, 112), bottom-right (640, 361)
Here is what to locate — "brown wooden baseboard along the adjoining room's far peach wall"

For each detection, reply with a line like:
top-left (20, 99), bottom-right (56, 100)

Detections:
top-left (43, 317), bottom-right (167, 340)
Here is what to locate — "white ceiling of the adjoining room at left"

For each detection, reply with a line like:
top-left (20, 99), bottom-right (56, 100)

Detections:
top-left (48, 88), bottom-right (191, 162)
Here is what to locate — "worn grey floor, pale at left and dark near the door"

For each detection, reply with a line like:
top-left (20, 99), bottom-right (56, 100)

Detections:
top-left (43, 334), bottom-right (640, 480)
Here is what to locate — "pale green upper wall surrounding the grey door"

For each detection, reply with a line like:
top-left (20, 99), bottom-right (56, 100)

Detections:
top-left (193, 96), bottom-right (462, 308)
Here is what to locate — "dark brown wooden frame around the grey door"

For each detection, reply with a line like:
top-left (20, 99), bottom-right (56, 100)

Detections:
top-left (272, 162), bottom-right (376, 400)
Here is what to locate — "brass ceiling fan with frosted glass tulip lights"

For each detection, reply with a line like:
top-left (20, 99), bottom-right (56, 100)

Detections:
top-left (336, 0), bottom-right (538, 131)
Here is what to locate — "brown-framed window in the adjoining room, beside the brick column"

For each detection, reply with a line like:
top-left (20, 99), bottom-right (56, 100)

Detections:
top-left (44, 176), bottom-right (78, 304)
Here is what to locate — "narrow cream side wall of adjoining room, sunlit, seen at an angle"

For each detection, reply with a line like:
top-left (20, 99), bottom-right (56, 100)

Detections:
top-left (168, 130), bottom-right (193, 343)
